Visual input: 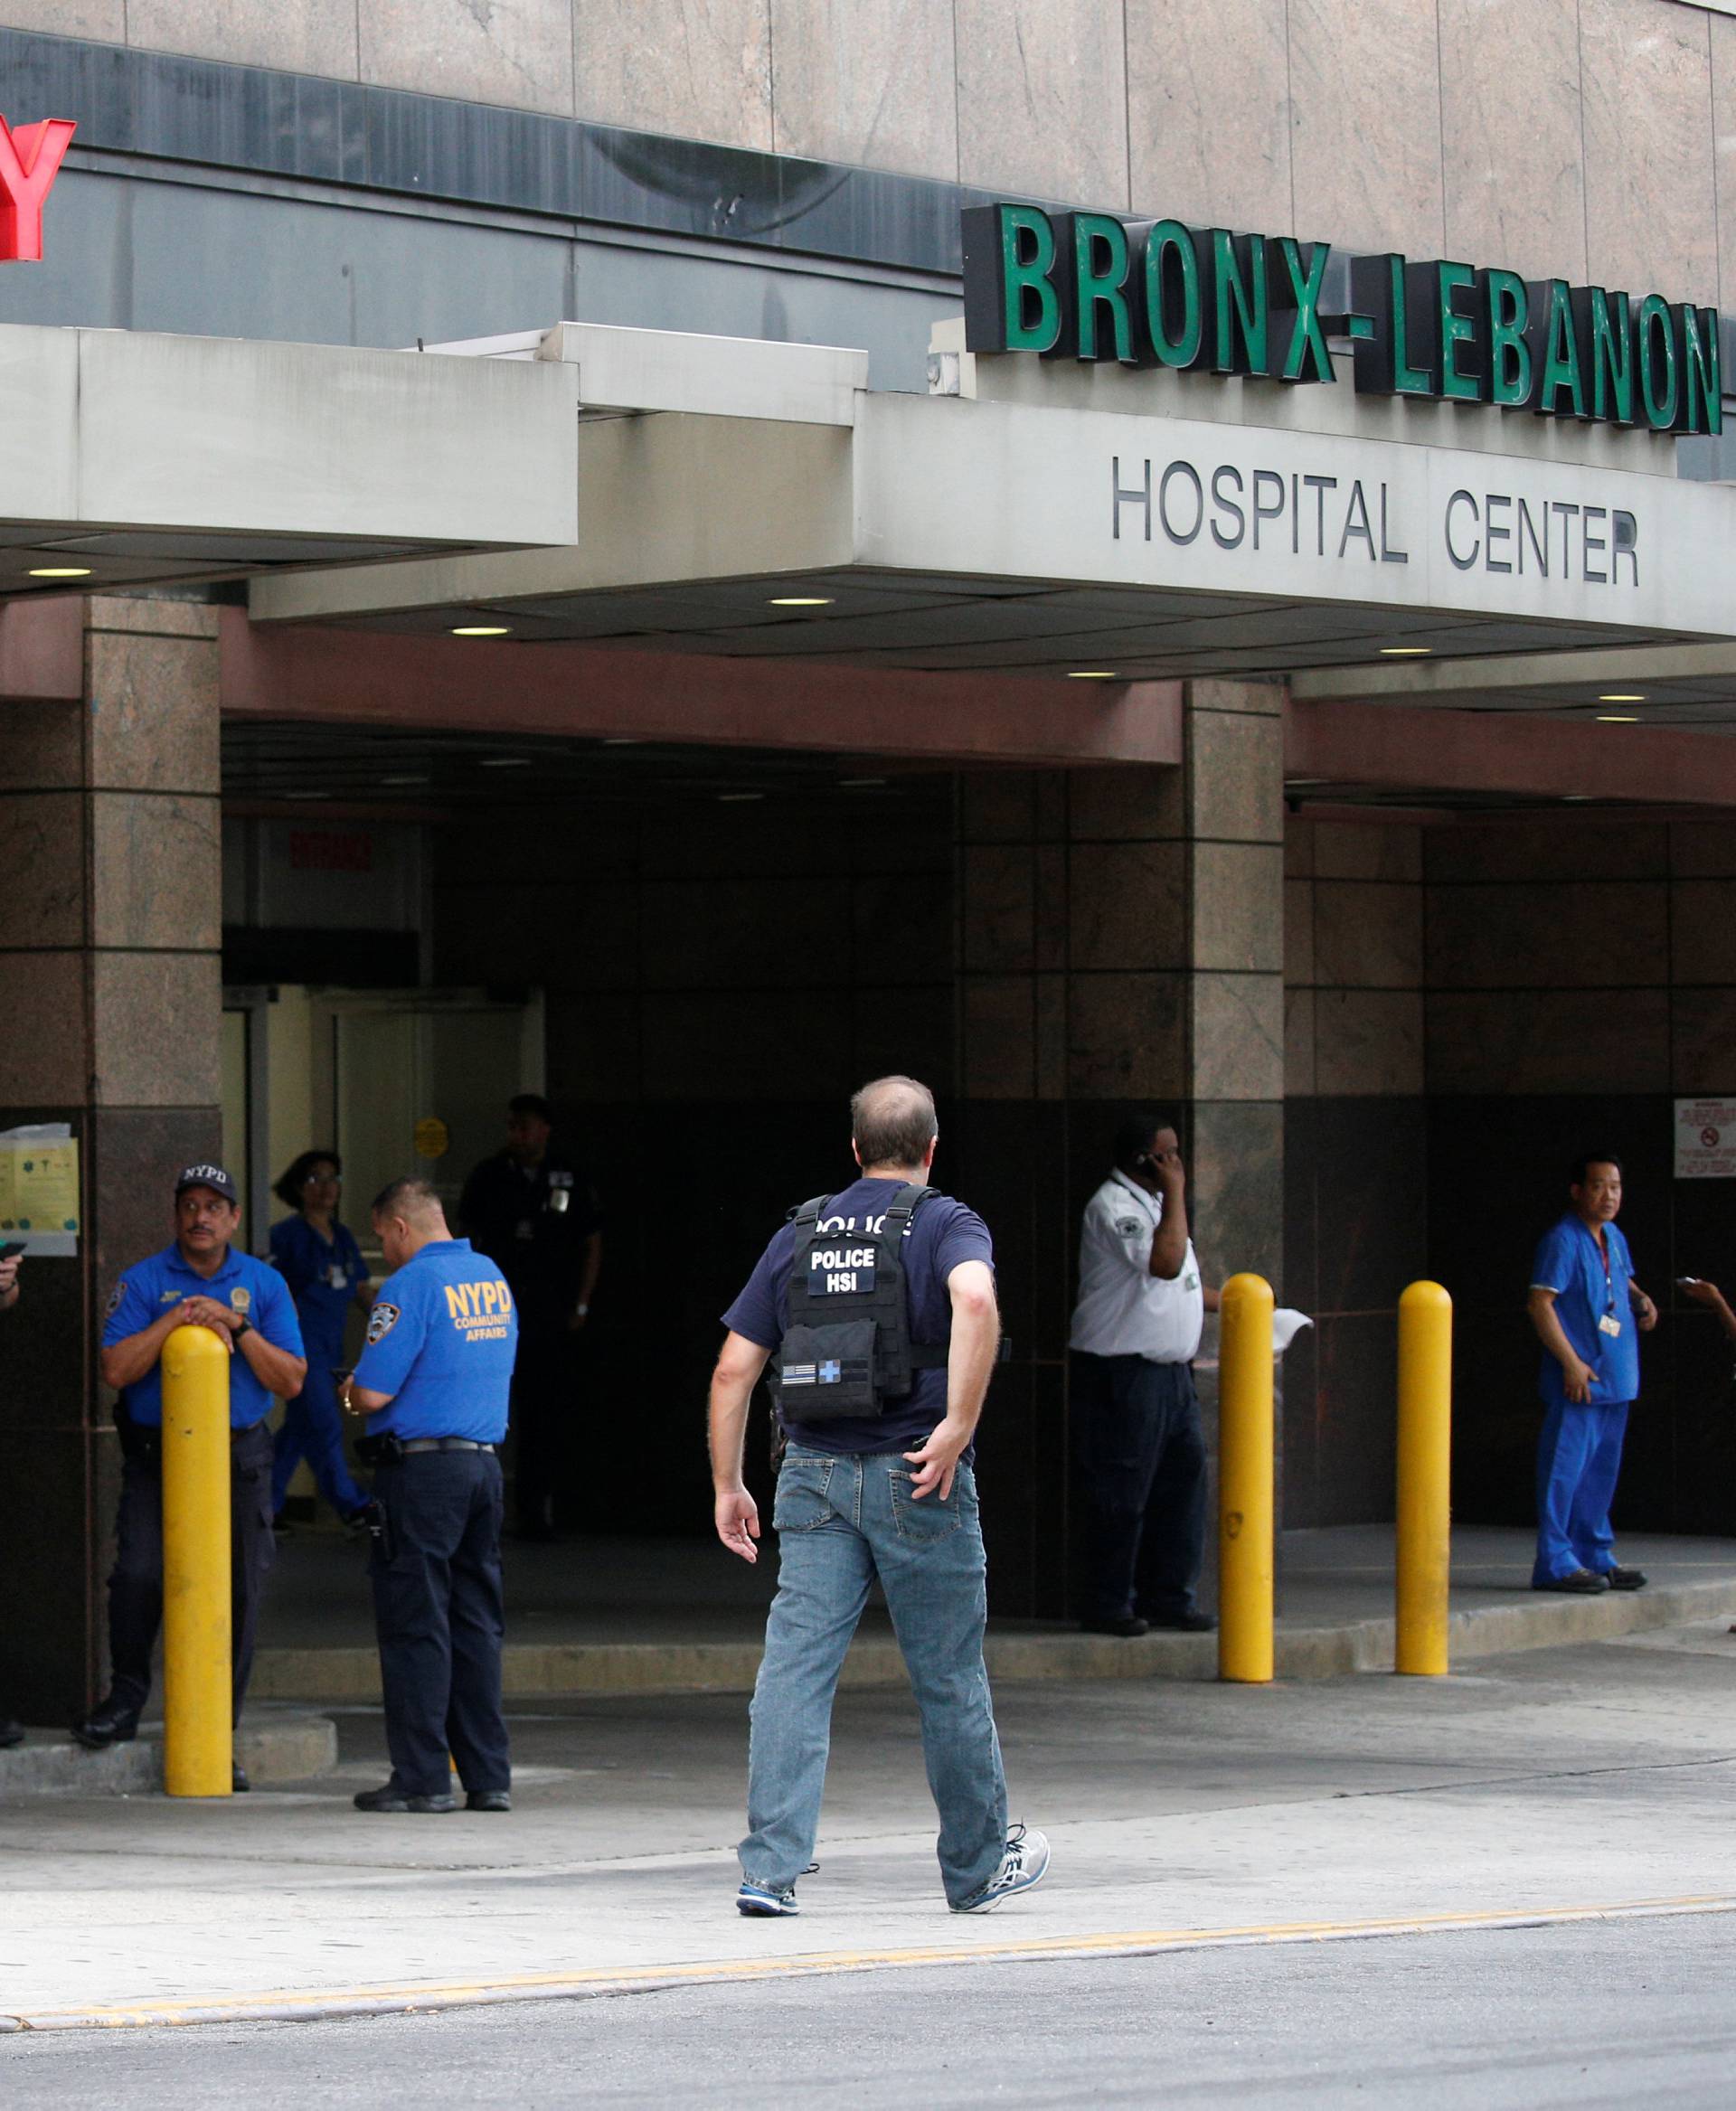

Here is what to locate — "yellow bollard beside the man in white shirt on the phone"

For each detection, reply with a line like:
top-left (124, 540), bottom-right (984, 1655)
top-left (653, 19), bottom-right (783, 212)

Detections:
top-left (1219, 1275), bottom-right (1273, 1684)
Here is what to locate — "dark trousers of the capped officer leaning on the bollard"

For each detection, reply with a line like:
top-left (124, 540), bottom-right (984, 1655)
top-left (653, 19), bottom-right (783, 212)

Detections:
top-left (108, 1423), bottom-right (277, 1722)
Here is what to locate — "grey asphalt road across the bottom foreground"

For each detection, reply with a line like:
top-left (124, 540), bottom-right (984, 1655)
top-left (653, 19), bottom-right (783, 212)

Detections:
top-left (0, 1915), bottom-right (1736, 2111)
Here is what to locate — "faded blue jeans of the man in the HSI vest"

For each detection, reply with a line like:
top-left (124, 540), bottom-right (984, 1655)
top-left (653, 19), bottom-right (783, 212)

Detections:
top-left (741, 1444), bottom-right (1007, 1907)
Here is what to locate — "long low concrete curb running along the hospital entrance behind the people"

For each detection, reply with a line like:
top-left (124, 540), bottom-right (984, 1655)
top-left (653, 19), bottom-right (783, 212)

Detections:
top-left (251, 1577), bottom-right (1736, 1703)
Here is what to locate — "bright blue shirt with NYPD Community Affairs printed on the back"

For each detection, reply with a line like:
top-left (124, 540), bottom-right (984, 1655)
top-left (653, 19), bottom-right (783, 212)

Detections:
top-left (354, 1239), bottom-right (517, 1444)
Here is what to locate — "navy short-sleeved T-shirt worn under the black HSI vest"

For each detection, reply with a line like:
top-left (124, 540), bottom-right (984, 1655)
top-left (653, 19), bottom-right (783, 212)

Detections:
top-left (722, 1180), bottom-right (995, 1461)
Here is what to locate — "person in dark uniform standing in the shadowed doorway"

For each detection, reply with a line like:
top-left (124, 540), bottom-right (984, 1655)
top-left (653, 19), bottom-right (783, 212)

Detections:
top-left (458, 1091), bottom-right (602, 1539)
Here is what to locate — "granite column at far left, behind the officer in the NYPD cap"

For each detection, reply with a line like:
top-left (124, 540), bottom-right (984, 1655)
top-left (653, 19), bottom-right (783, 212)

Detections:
top-left (0, 599), bottom-right (222, 1722)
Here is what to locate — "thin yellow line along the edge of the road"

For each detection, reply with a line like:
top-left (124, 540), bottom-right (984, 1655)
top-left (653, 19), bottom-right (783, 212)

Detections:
top-left (0, 1893), bottom-right (1736, 2033)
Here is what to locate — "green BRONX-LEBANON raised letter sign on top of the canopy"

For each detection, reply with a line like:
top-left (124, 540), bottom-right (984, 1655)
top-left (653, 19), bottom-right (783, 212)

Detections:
top-left (961, 204), bottom-right (1723, 433)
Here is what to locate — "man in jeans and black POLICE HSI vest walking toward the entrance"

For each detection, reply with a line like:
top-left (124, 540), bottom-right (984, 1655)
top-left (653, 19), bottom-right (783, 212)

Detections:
top-left (712, 1077), bottom-right (1050, 1917)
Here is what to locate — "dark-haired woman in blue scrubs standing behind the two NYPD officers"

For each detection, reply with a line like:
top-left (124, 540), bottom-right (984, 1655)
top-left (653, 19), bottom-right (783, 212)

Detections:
top-left (270, 1151), bottom-right (373, 1524)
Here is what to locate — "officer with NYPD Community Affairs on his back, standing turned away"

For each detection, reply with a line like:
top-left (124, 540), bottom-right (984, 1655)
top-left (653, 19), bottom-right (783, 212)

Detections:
top-left (340, 1180), bottom-right (517, 1814)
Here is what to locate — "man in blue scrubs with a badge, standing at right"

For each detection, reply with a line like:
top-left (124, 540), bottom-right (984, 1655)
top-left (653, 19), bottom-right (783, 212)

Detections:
top-left (1527, 1153), bottom-right (1658, 1596)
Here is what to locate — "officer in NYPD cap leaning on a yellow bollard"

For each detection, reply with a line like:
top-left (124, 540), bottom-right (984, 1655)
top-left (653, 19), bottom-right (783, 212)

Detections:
top-left (71, 1165), bottom-right (307, 1788)
